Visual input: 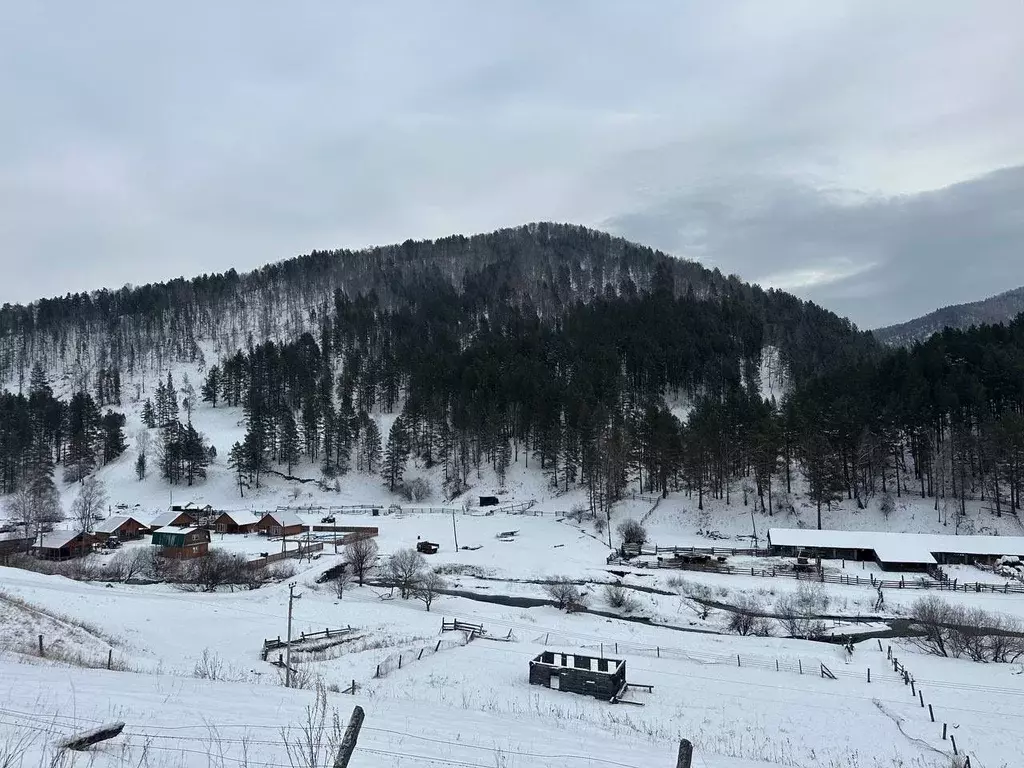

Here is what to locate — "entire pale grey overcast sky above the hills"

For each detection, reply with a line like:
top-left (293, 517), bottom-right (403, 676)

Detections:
top-left (0, 0), bottom-right (1024, 328)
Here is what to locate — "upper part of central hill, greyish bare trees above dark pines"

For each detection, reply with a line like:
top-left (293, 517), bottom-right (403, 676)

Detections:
top-left (0, 223), bottom-right (871, 392)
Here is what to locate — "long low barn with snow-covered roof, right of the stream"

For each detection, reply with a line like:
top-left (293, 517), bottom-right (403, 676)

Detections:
top-left (768, 528), bottom-right (1024, 572)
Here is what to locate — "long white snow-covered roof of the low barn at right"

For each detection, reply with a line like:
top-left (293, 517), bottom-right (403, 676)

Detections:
top-left (768, 528), bottom-right (1024, 565)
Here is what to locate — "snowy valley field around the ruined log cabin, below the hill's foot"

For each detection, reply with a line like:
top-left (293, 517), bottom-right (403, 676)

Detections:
top-left (0, 505), bottom-right (1024, 768)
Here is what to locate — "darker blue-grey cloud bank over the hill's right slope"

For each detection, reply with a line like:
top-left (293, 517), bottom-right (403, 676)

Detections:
top-left (607, 166), bottom-right (1024, 328)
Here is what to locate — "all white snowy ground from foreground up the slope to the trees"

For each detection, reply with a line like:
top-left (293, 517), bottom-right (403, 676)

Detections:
top-left (0, 367), bottom-right (1024, 768)
